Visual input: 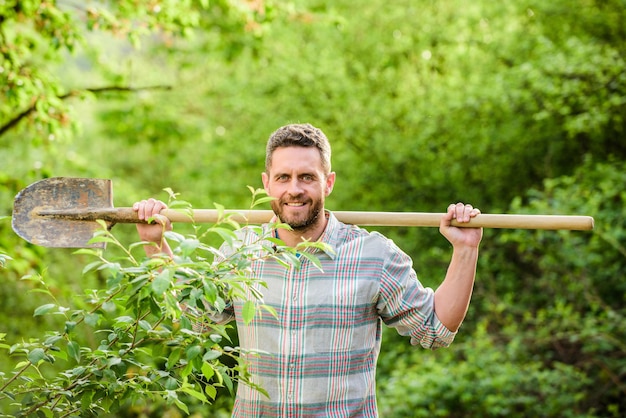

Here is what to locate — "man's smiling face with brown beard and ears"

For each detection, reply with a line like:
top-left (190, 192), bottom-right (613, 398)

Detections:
top-left (263, 146), bottom-right (335, 231)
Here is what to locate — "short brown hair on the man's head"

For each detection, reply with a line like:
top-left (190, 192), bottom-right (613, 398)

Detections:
top-left (265, 123), bottom-right (330, 174)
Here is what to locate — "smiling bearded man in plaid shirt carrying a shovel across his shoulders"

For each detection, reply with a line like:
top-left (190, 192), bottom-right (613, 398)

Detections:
top-left (133, 124), bottom-right (482, 417)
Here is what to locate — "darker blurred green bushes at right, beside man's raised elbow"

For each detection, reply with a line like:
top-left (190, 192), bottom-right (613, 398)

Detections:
top-left (380, 159), bottom-right (626, 417)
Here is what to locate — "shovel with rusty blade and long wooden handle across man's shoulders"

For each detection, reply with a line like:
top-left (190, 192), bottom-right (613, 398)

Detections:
top-left (12, 177), bottom-right (594, 248)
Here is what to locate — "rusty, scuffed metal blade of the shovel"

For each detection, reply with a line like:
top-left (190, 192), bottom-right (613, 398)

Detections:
top-left (12, 177), bottom-right (113, 248)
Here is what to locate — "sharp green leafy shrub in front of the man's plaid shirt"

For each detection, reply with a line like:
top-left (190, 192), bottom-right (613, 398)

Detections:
top-left (0, 194), bottom-right (330, 417)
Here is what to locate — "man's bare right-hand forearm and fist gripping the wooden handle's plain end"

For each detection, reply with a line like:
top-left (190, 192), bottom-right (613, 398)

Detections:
top-left (435, 203), bottom-right (483, 332)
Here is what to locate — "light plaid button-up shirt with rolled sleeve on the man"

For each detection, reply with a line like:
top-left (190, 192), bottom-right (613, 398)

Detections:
top-left (213, 213), bottom-right (455, 418)
